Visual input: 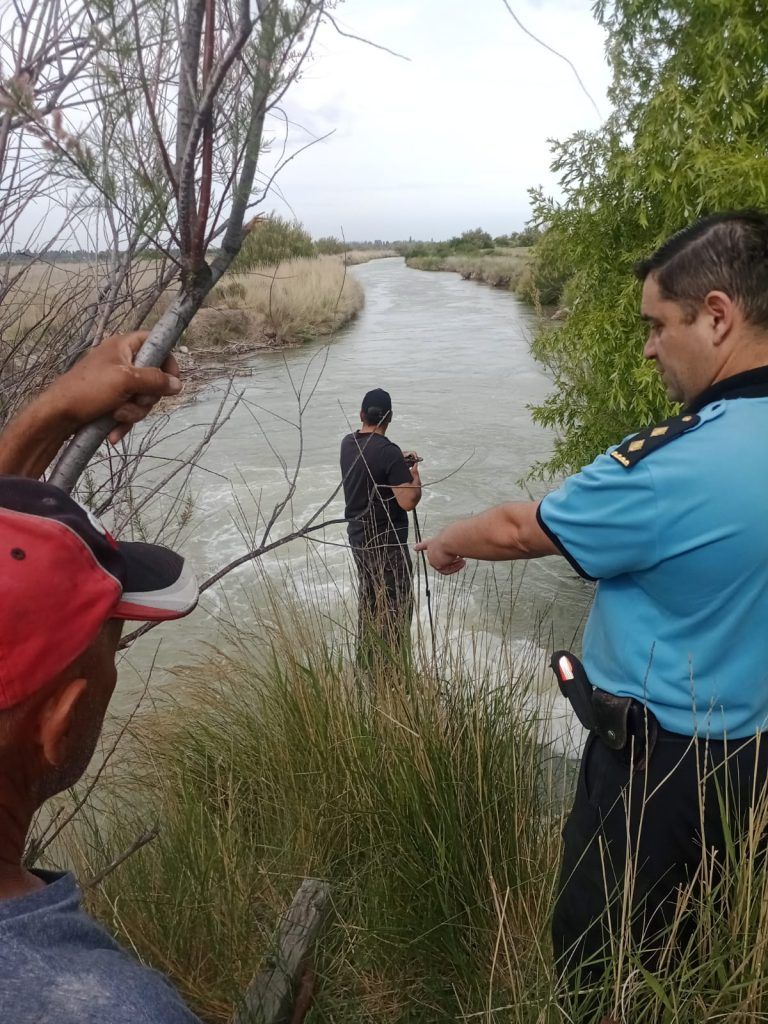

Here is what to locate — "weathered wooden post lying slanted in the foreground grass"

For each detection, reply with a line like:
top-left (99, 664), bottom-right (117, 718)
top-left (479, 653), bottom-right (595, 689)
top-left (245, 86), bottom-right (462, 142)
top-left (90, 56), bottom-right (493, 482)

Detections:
top-left (234, 879), bottom-right (331, 1024)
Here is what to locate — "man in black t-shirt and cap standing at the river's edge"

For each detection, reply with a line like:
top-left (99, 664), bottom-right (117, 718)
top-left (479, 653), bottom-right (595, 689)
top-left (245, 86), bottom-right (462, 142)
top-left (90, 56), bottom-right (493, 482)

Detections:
top-left (340, 388), bottom-right (421, 668)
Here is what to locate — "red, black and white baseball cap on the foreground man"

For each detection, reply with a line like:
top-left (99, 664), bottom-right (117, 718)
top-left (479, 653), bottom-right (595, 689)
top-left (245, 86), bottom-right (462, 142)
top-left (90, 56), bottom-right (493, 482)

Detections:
top-left (0, 476), bottom-right (199, 711)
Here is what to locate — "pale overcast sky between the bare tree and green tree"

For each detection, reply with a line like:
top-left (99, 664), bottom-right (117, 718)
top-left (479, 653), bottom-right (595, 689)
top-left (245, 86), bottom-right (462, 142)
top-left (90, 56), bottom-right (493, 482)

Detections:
top-left (267, 0), bottom-right (609, 240)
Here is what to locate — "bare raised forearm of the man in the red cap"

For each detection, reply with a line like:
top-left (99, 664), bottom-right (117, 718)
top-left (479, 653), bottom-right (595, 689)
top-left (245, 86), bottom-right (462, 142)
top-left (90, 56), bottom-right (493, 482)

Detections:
top-left (0, 394), bottom-right (76, 478)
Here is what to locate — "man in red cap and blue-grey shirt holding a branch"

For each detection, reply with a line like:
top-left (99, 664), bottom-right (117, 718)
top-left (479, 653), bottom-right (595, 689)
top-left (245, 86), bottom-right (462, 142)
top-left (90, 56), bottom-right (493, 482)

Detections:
top-left (0, 333), bottom-right (198, 1024)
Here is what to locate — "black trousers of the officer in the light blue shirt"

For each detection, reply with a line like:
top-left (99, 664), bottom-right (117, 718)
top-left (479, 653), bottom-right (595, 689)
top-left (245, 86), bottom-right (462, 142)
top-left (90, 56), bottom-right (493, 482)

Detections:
top-left (552, 729), bottom-right (768, 982)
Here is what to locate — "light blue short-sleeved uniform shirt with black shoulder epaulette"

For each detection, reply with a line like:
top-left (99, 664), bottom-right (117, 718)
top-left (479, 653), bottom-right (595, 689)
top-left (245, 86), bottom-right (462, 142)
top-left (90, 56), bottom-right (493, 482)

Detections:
top-left (539, 387), bottom-right (768, 738)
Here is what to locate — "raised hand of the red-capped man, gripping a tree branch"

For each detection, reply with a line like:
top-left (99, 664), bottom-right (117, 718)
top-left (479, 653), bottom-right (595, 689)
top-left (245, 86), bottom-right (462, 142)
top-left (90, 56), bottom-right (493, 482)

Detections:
top-left (39, 331), bottom-right (181, 444)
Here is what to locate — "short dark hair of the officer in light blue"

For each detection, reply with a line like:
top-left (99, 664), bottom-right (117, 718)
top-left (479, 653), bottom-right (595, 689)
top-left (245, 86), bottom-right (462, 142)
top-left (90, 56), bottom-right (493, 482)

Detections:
top-left (635, 210), bottom-right (768, 327)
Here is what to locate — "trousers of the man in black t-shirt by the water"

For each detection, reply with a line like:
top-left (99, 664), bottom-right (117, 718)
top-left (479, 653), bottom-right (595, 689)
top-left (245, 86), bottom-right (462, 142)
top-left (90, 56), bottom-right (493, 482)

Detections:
top-left (352, 542), bottom-right (414, 667)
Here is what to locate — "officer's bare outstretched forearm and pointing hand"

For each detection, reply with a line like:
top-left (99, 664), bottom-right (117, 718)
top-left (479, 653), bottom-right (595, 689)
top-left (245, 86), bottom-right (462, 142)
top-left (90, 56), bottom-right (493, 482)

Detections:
top-left (416, 502), bottom-right (560, 575)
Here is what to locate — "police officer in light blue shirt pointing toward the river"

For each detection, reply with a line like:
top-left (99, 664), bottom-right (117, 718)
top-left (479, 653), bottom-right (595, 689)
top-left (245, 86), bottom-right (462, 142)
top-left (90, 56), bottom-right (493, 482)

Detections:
top-left (421, 211), bottom-right (768, 976)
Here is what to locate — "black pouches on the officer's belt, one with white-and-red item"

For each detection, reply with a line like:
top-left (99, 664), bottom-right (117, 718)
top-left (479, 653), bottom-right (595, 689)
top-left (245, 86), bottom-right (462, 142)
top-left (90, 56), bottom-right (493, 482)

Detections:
top-left (550, 650), bottom-right (658, 769)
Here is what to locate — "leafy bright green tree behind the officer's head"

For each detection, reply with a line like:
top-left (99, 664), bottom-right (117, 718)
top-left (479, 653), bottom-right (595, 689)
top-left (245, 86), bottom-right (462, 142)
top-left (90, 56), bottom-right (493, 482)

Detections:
top-left (531, 0), bottom-right (768, 476)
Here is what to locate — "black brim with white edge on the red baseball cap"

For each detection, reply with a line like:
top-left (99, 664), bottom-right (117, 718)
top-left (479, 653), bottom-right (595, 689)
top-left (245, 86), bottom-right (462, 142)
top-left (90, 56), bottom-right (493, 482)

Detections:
top-left (111, 542), bottom-right (200, 622)
